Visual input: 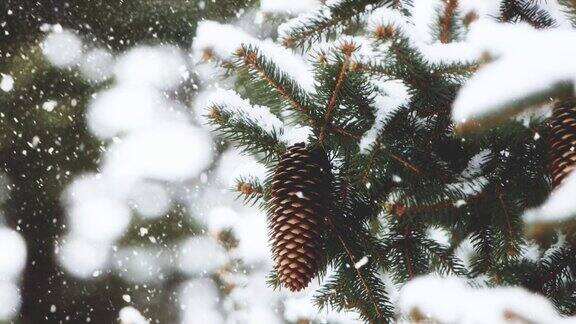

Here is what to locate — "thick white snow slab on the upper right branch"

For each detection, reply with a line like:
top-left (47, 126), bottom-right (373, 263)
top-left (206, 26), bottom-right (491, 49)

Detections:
top-left (452, 22), bottom-right (576, 124)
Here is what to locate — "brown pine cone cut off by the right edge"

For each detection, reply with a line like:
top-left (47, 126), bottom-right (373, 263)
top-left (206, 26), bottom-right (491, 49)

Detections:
top-left (549, 100), bottom-right (576, 189)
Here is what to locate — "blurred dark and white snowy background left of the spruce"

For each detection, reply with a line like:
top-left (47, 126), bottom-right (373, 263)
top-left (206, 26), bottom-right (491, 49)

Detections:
top-left (0, 0), bottom-right (354, 323)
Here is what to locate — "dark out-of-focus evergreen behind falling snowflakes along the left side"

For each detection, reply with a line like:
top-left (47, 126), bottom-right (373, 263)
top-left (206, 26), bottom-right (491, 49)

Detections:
top-left (0, 0), bottom-right (253, 323)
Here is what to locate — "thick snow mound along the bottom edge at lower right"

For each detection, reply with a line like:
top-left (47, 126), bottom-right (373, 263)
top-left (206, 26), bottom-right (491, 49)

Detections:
top-left (398, 276), bottom-right (574, 324)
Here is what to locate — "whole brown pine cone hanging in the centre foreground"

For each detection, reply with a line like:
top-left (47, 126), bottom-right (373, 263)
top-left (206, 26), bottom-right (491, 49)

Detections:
top-left (269, 143), bottom-right (331, 291)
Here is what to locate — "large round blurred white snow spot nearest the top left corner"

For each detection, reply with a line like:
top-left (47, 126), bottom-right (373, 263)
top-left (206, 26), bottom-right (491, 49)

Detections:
top-left (42, 30), bottom-right (82, 68)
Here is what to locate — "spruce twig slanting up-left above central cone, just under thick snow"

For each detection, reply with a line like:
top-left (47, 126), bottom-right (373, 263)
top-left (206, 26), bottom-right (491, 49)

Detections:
top-left (236, 45), bottom-right (317, 127)
